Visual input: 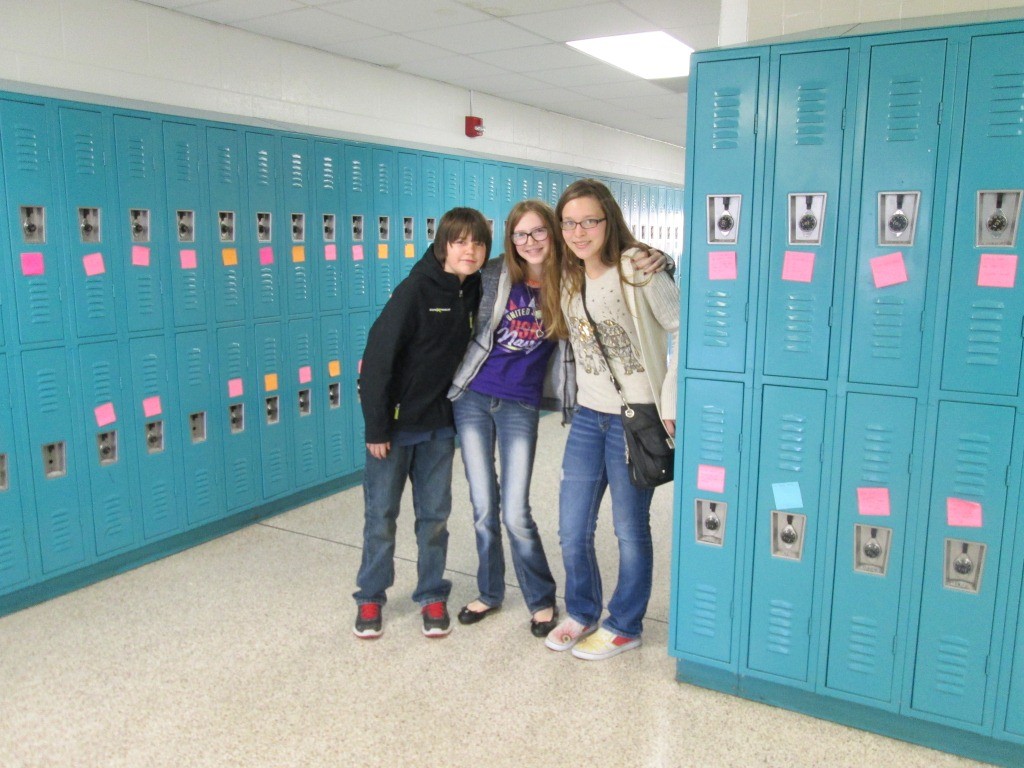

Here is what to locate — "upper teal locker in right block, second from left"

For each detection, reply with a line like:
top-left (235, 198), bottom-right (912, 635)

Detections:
top-left (763, 49), bottom-right (850, 379)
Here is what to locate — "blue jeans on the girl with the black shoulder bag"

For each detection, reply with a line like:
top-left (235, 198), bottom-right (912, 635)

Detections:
top-left (558, 407), bottom-right (654, 638)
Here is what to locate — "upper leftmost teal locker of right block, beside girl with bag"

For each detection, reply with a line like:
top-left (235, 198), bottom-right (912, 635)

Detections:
top-left (684, 58), bottom-right (761, 373)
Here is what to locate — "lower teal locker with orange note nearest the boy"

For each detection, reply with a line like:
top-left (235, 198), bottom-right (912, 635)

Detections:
top-left (316, 314), bottom-right (357, 478)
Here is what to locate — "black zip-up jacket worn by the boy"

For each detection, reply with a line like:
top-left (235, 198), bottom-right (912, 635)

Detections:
top-left (359, 245), bottom-right (480, 442)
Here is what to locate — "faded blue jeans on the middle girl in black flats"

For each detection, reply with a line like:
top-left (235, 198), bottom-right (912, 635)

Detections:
top-left (454, 391), bottom-right (555, 613)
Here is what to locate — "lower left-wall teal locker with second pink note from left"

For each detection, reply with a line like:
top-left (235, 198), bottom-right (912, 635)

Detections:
top-left (128, 336), bottom-right (178, 540)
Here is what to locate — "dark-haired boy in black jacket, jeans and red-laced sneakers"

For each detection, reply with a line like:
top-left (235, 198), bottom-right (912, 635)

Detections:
top-left (353, 208), bottom-right (490, 638)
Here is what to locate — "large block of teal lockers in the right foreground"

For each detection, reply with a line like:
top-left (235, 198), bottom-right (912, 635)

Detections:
top-left (670, 24), bottom-right (1024, 765)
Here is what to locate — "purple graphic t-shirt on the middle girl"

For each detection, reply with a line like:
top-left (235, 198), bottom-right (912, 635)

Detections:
top-left (469, 283), bottom-right (555, 408)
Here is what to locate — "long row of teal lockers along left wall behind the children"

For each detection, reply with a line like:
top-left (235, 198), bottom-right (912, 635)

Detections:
top-left (0, 87), bottom-right (682, 613)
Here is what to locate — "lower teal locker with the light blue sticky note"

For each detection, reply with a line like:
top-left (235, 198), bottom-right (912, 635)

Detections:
top-left (746, 386), bottom-right (826, 684)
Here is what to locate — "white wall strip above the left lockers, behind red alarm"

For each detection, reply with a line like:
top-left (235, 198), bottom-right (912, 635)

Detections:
top-left (0, 0), bottom-right (685, 184)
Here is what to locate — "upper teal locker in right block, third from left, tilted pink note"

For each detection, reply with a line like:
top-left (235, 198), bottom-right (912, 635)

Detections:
top-left (850, 40), bottom-right (946, 387)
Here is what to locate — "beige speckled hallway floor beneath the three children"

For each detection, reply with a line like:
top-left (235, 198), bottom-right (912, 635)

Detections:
top-left (0, 418), bottom-right (991, 768)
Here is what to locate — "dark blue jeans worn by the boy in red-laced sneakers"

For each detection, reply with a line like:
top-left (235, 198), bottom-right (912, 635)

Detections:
top-left (352, 437), bottom-right (455, 605)
